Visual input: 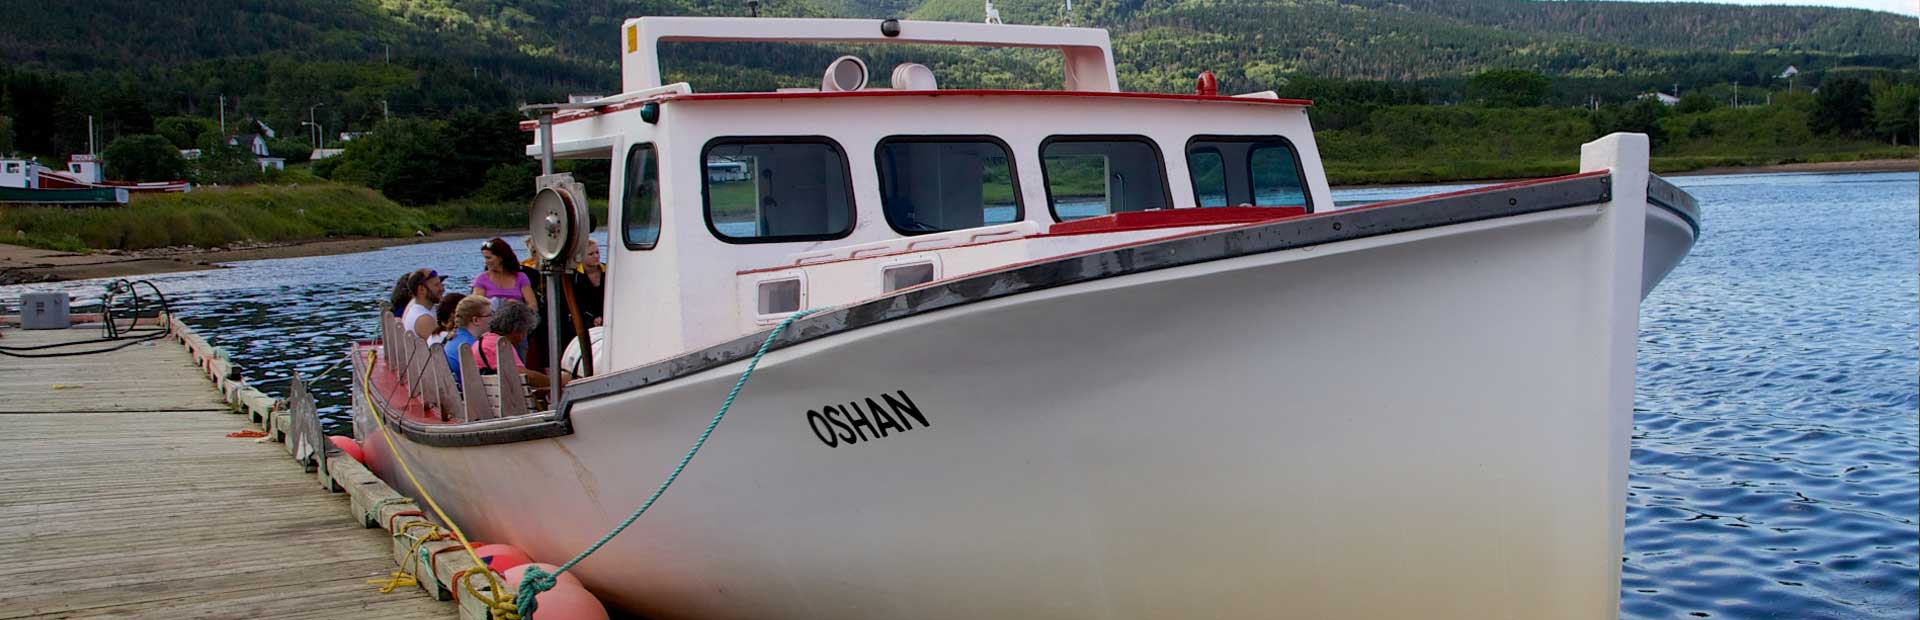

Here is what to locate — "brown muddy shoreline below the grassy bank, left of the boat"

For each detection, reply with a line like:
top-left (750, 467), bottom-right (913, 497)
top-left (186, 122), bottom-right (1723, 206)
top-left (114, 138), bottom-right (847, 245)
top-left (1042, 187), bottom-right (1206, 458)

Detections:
top-left (0, 228), bottom-right (516, 286)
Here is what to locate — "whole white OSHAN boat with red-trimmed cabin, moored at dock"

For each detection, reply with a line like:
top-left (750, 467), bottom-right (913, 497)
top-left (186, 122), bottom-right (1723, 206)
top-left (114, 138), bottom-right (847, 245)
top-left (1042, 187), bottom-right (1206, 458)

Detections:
top-left (349, 17), bottom-right (1699, 618)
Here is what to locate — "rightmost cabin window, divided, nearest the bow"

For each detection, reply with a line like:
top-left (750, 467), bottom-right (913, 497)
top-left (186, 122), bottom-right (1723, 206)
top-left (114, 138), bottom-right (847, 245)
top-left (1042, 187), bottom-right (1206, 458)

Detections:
top-left (1187, 136), bottom-right (1311, 207)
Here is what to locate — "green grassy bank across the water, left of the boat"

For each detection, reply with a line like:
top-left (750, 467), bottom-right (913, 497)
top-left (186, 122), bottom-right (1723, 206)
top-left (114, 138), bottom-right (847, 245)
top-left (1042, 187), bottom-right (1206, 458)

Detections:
top-left (0, 182), bottom-right (541, 251)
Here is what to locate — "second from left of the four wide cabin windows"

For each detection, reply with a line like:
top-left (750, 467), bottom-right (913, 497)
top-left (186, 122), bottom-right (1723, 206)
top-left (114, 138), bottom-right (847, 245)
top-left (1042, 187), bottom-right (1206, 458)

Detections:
top-left (874, 136), bottom-right (1021, 234)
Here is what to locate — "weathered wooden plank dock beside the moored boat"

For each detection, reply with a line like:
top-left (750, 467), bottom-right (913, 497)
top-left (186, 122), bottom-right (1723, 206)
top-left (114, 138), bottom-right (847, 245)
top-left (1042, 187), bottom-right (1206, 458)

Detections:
top-left (0, 328), bottom-right (457, 618)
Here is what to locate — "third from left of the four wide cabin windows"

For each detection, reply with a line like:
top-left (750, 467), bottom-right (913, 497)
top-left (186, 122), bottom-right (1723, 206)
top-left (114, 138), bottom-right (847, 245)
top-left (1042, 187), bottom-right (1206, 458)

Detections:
top-left (1041, 136), bottom-right (1173, 221)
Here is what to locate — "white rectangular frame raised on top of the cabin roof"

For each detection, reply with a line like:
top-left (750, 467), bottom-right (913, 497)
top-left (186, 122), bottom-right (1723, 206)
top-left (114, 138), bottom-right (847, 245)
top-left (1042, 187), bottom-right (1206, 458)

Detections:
top-left (620, 17), bottom-right (1119, 92)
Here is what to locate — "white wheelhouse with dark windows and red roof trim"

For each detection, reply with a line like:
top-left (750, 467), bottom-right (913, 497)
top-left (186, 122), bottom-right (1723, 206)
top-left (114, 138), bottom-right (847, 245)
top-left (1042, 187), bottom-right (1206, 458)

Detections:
top-left (524, 17), bottom-right (1332, 369)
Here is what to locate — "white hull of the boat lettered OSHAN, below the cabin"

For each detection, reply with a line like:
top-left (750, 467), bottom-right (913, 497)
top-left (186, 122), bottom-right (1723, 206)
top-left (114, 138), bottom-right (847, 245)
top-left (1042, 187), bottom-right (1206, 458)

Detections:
top-left (357, 137), bottom-right (1693, 618)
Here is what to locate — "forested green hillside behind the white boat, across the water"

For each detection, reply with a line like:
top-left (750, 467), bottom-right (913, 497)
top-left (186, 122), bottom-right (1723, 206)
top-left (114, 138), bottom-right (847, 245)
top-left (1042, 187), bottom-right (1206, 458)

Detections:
top-left (0, 0), bottom-right (1920, 152)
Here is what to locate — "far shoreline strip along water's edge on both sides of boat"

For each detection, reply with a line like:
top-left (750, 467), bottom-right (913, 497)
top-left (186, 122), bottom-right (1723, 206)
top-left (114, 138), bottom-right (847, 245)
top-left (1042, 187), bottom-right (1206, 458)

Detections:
top-left (0, 159), bottom-right (1920, 286)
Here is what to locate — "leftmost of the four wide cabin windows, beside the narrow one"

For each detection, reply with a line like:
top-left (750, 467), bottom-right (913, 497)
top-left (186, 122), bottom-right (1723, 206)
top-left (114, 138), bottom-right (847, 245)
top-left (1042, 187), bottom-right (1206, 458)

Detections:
top-left (701, 138), bottom-right (852, 244)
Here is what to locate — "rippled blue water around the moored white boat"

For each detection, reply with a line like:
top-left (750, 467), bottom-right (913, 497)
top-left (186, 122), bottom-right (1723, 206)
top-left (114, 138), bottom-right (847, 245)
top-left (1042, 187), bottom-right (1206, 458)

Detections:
top-left (0, 173), bottom-right (1920, 618)
